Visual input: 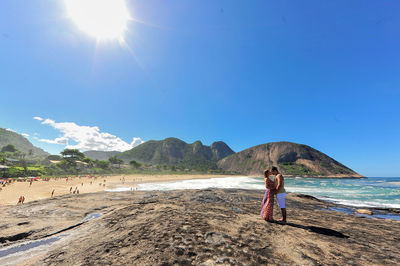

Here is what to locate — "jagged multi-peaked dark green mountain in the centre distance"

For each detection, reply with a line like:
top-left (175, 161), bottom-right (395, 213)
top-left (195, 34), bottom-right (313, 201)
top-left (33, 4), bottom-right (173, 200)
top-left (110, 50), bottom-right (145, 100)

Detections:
top-left (117, 138), bottom-right (234, 169)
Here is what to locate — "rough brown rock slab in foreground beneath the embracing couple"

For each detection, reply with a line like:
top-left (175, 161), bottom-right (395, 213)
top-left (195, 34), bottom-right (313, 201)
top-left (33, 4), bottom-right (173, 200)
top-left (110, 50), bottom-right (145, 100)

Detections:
top-left (0, 189), bottom-right (400, 265)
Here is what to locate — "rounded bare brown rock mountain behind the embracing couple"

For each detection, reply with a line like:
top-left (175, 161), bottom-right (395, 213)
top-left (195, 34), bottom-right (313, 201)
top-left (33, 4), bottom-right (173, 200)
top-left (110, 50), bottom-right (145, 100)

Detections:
top-left (217, 142), bottom-right (362, 177)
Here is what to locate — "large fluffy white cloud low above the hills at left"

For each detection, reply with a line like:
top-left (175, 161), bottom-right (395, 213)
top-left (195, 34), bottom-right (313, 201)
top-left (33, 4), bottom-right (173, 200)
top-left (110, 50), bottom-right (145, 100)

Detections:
top-left (36, 118), bottom-right (143, 151)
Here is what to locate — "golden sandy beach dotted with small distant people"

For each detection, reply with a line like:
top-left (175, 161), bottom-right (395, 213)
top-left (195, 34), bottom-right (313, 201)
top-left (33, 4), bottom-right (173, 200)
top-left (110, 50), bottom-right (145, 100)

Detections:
top-left (0, 174), bottom-right (231, 206)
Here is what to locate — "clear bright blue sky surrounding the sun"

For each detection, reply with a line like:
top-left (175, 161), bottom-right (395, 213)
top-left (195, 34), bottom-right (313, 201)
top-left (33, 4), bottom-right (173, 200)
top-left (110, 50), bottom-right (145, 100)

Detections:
top-left (0, 0), bottom-right (400, 176)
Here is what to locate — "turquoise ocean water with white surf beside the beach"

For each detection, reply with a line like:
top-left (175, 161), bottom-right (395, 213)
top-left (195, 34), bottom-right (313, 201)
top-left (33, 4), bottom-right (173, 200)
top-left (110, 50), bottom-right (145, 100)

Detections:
top-left (134, 177), bottom-right (400, 208)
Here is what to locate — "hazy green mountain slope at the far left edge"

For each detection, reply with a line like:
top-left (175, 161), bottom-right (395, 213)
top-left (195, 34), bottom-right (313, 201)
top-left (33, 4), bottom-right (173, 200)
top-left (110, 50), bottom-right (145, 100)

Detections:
top-left (0, 128), bottom-right (50, 159)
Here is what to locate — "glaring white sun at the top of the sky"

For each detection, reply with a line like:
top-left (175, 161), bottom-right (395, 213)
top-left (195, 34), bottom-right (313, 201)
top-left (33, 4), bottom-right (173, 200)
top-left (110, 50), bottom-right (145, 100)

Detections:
top-left (65, 0), bottom-right (130, 40)
